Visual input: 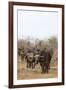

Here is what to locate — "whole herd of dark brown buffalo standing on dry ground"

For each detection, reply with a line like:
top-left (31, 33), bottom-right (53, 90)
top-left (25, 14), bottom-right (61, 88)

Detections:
top-left (18, 48), bottom-right (52, 73)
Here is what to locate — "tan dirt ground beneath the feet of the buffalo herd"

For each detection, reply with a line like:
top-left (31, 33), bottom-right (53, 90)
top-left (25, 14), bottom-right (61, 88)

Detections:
top-left (17, 57), bottom-right (57, 80)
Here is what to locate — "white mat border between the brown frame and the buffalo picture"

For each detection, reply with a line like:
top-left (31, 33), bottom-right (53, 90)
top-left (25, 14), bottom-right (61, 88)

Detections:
top-left (13, 5), bottom-right (62, 85)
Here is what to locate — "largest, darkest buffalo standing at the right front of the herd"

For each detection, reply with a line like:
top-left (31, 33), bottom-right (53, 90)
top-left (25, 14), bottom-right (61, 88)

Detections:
top-left (39, 49), bottom-right (51, 73)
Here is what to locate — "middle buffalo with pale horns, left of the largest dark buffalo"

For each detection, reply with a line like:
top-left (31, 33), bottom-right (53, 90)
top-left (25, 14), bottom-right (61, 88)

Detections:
top-left (26, 50), bottom-right (40, 69)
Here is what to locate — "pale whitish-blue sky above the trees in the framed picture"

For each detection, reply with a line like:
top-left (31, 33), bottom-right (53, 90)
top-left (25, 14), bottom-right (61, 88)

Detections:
top-left (17, 10), bottom-right (58, 39)
